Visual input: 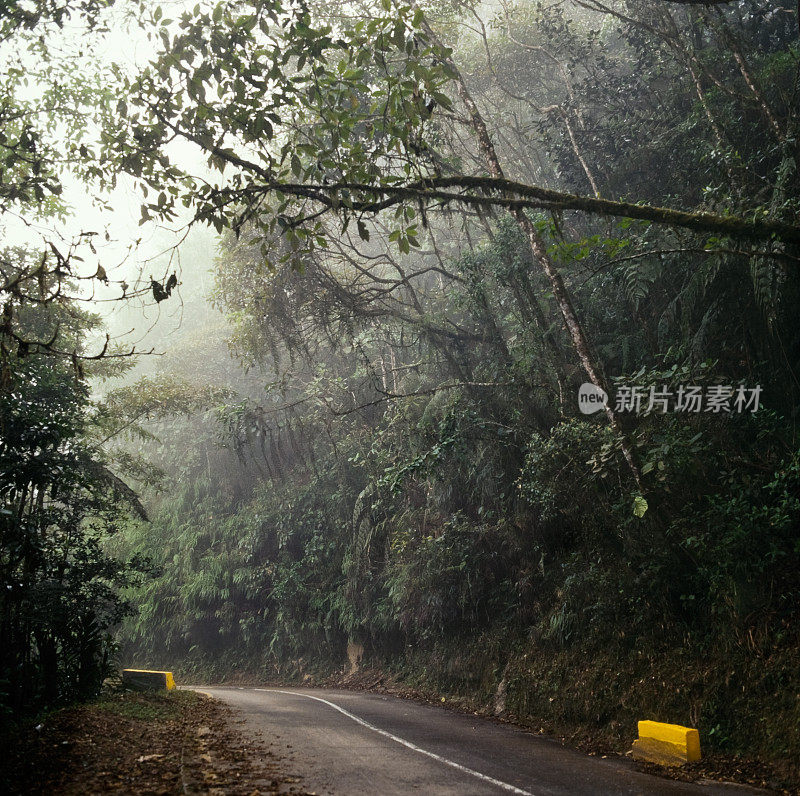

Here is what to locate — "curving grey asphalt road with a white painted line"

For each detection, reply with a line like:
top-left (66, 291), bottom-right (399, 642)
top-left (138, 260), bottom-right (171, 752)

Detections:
top-left (192, 686), bottom-right (754, 796)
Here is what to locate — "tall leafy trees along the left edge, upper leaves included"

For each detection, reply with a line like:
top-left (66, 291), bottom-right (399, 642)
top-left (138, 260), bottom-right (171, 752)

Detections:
top-left (0, 0), bottom-right (158, 719)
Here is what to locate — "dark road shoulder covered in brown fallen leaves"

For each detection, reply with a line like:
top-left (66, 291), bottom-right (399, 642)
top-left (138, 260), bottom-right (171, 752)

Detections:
top-left (0, 691), bottom-right (303, 796)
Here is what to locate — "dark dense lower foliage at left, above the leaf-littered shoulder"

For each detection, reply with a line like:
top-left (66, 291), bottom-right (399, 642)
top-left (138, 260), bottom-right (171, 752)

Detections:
top-left (0, 350), bottom-right (150, 715)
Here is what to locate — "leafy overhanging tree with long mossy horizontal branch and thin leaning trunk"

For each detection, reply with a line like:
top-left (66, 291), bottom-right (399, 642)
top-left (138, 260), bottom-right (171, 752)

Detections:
top-left (107, 2), bottom-right (800, 489)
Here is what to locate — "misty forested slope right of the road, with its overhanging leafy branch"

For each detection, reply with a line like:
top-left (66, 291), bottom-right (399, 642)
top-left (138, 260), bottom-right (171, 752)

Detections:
top-left (1, 0), bottom-right (800, 768)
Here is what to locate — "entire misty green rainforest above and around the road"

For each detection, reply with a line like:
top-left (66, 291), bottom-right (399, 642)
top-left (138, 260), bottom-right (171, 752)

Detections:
top-left (0, 0), bottom-right (800, 788)
